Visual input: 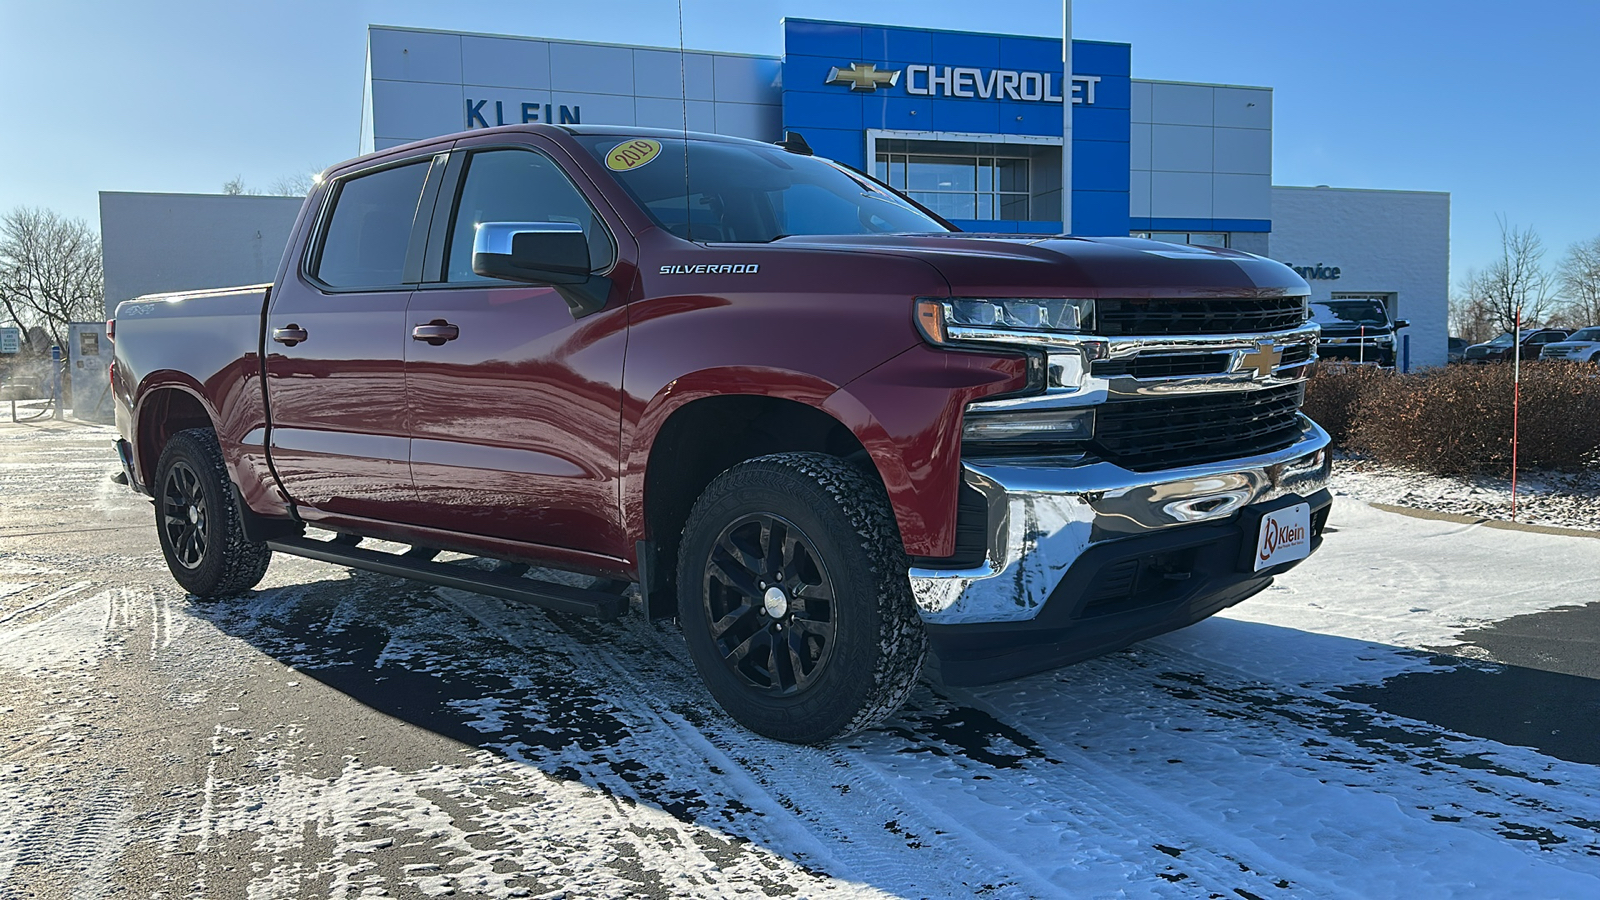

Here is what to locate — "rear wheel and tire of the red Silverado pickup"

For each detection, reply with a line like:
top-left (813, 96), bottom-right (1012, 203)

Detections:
top-left (152, 428), bottom-right (272, 599)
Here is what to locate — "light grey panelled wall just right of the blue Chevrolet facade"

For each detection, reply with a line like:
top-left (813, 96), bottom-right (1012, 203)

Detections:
top-left (1128, 78), bottom-right (1272, 231)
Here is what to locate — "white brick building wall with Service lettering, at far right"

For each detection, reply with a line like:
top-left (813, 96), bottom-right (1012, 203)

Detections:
top-left (1269, 187), bottom-right (1450, 368)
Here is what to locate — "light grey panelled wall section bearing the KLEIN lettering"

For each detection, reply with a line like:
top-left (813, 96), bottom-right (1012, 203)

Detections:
top-left (363, 26), bottom-right (782, 151)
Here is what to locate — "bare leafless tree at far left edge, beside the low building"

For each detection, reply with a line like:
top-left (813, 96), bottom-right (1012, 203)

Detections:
top-left (0, 207), bottom-right (106, 349)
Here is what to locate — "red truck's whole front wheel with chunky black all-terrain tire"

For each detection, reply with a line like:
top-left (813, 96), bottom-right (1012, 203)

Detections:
top-left (678, 453), bottom-right (928, 743)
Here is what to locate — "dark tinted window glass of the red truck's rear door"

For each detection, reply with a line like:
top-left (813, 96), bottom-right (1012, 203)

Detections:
top-left (312, 160), bottom-right (429, 288)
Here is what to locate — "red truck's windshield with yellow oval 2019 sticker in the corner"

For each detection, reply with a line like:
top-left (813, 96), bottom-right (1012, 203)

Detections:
top-left (574, 135), bottom-right (950, 243)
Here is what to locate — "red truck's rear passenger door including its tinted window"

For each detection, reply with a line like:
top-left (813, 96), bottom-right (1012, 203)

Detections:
top-left (266, 155), bottom-right (446, 519)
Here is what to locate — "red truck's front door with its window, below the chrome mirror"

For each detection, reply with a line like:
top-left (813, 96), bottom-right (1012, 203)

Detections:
top-left (405, 141), bottom-right (627, 556)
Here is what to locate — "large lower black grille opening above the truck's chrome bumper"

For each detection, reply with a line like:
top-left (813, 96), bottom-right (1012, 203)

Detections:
top-left (1094, 384), bottom-right (1304, 472)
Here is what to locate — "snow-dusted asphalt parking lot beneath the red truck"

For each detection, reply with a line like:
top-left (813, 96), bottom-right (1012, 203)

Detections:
top-left (0, 423), bottom-right (1600, 900)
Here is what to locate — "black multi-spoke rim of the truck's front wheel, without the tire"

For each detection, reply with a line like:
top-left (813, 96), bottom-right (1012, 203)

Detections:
top-left (702, 512), bottom-right (838, 695)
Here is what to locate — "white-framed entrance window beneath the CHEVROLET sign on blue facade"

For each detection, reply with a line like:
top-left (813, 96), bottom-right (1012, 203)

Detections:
top-left (874, 139), bottom-right (1034, 221)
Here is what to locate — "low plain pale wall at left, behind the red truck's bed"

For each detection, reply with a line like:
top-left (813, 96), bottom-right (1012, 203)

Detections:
top-left (99, 191), bottom-right (304, 317)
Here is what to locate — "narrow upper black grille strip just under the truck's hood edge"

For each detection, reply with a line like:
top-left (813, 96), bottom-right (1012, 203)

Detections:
top-left (1094, 296), bottom-right (1306, 338)
